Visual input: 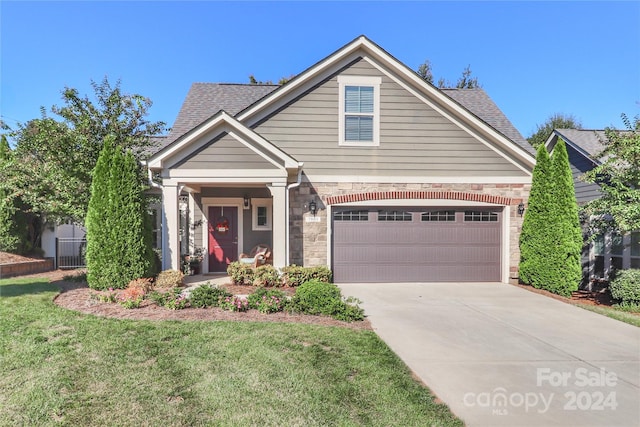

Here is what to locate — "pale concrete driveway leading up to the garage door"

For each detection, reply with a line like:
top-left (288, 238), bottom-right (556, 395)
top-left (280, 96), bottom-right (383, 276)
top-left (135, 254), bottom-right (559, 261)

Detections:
top-left (340, 283), bottom-right (640, 427)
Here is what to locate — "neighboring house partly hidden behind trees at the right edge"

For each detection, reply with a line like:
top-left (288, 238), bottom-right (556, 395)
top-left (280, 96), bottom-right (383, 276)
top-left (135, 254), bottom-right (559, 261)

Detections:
top-left (546, 129), bottom-right (640, 286)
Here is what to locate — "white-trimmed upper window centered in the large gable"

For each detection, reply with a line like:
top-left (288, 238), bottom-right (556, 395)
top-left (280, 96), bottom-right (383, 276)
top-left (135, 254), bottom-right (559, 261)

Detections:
top-left (338, 76), bottom-right (382, 146)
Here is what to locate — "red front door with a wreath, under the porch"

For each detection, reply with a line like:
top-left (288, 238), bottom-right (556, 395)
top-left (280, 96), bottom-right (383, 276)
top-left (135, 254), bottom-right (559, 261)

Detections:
top-left (209, 206), bottom-right (238, 272)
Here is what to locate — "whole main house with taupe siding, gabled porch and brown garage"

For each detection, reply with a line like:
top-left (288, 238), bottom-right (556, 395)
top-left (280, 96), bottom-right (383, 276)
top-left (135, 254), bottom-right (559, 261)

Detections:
top-left (148, 36), bottom-right (535, 282)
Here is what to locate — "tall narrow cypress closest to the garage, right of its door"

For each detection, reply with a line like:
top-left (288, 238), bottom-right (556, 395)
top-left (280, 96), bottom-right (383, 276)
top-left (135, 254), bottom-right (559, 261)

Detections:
top-left (519, 144), bottom-right (553, 288)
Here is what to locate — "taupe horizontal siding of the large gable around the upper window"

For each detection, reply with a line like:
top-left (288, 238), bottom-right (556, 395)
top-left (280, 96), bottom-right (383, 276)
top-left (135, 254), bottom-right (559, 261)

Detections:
top-left (255, 59), bottom-right (524, 176)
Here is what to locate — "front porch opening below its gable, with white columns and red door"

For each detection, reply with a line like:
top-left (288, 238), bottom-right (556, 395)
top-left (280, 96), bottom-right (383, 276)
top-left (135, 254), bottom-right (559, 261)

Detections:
top-left (162, 183), bottom-right (288, 274)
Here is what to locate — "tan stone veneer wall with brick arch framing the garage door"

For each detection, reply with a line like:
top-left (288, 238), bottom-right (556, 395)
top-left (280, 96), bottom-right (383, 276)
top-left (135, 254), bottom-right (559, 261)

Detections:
top-left (289, 182), bottom-right (531, 278)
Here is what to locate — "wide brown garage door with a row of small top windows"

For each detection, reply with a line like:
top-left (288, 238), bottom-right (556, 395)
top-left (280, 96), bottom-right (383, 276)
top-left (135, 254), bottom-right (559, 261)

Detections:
top-left (333, 207), bottom-right (502, 283)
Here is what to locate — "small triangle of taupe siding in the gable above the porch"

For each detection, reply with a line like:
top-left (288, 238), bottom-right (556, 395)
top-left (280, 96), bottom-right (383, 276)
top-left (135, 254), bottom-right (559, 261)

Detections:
top-left (175, 133), bottom-right (275, 169)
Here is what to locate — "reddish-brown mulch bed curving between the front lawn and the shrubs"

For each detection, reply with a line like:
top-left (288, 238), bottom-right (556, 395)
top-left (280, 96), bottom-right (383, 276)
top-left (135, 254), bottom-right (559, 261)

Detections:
top-left (12, 270), bottom-right (372, 330)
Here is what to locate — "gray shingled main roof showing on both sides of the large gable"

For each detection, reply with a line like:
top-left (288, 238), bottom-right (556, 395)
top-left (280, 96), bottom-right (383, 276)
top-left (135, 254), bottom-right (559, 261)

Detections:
top-left (158, 83), bottom-right (535, 155)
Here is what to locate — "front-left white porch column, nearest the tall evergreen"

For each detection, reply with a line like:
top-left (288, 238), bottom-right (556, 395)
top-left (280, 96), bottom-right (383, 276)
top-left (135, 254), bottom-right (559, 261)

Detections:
top-left (162, 185), bottom-right (180, 270)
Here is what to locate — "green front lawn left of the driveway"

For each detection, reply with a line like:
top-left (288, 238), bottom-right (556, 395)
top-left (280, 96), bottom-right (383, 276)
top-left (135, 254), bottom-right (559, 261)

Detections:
top-left (0, 279), bottom-right (462, 427)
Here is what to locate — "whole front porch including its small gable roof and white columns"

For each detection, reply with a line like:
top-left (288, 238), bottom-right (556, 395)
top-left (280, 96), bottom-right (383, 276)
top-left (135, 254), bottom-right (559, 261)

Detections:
top-left (147, 111), bottom-right (303, 273)
